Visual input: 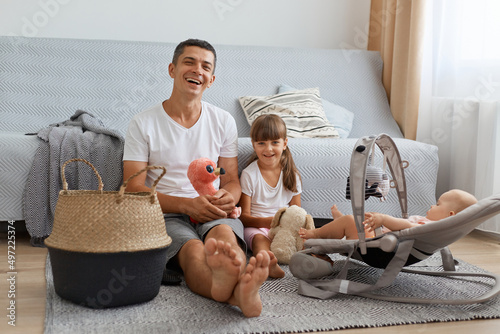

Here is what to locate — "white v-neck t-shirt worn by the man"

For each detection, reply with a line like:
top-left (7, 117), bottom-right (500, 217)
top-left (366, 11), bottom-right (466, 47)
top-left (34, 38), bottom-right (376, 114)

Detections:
top-left (123, 102), bottom-right (238, 198)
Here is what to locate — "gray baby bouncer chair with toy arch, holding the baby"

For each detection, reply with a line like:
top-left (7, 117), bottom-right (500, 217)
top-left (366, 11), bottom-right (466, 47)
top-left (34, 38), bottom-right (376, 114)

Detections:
top-left (290, 134), bottom-right (500, 304)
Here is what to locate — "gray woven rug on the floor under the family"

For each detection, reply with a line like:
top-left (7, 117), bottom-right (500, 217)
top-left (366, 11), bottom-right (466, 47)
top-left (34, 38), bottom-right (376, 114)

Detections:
top-left (45, 253), bottom-right (500, 334)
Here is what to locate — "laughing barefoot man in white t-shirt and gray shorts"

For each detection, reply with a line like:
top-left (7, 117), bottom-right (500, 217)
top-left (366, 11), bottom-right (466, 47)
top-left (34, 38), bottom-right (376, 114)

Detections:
top-left (123, 39), bottom-right (270, 317)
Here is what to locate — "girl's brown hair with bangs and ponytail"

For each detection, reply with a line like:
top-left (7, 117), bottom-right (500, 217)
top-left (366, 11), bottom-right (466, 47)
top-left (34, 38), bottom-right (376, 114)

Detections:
top-left (249, 114), bottom-right (302, 192)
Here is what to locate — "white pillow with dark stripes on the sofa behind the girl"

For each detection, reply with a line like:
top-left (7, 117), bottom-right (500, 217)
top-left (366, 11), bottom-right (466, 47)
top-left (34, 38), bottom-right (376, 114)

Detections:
top-left (239, 88), bottom-right (339, 138)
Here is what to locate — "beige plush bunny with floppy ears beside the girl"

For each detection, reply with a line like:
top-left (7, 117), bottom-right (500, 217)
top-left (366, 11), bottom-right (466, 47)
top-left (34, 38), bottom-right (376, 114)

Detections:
top-left (268, 205), bottom-right (314, 264)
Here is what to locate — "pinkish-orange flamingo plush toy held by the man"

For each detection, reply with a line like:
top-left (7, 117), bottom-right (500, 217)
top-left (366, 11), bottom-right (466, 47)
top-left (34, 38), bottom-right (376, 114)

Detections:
top-left (188, 158), bottom-right (241, 223)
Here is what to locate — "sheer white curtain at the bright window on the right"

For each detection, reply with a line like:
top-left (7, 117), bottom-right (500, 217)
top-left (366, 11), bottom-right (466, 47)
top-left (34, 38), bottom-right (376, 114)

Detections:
top-left (417, 0), bottom-right (500, 233)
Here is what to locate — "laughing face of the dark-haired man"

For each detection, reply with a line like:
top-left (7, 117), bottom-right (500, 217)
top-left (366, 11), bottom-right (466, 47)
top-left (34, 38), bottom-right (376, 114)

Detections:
top-left (168, 46), bottom-right (215, 95)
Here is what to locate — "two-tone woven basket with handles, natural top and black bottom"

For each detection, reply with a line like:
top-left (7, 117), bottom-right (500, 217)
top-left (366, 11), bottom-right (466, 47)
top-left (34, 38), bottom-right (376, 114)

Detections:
top-left (45, 159), bottom-right (172, 308)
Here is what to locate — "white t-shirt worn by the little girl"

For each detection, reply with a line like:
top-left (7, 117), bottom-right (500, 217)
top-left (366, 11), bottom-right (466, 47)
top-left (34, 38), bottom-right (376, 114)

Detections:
top-left (240, 160), bottom-right (302, 217)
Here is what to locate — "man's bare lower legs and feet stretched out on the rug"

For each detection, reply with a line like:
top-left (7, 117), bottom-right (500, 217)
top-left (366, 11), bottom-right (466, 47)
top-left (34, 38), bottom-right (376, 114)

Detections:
top-left (177, 225), bottom-right (271, 317)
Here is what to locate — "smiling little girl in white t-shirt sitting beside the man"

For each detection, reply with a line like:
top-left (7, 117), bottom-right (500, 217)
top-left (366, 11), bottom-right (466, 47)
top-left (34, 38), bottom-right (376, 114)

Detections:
top-left (240, 114), bottom-right (302, 278)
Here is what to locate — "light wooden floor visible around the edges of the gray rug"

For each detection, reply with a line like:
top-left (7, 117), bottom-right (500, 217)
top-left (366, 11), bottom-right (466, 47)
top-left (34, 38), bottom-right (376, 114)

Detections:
top-left (0, 231), bottom-right (500, 334)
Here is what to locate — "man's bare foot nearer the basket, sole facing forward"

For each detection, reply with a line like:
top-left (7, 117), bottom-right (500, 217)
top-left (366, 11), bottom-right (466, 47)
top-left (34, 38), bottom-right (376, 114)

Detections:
top-left (205, 238), bottom-right (242, 302)
